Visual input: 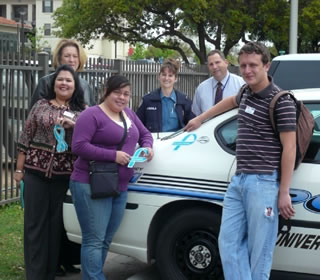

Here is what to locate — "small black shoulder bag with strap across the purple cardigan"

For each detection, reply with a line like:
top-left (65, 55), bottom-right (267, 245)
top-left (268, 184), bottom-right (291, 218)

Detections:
top-left (89, 112), bottom-right (127, 199)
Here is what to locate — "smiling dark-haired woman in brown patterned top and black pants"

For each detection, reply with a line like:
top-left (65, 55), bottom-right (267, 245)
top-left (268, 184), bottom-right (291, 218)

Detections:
top-left (14, 65), bottom-right (85, 280)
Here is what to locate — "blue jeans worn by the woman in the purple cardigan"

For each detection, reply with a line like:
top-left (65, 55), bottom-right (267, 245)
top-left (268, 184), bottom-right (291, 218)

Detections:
top-left (70, 180), bottom-right (128, 280)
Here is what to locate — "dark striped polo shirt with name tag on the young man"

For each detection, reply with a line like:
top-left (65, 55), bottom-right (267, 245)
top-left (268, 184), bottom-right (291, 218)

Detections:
top-left (236, 77), bottom-right (296, 174)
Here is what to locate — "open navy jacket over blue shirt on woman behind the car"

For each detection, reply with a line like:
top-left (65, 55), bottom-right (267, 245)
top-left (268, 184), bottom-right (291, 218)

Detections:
top-left (137, 88), bottom-right (195, 132)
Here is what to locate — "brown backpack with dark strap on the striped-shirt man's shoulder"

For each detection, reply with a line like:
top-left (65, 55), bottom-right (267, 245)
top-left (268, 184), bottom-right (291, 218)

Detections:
top-left (269, 90), bottom-right (314, 169)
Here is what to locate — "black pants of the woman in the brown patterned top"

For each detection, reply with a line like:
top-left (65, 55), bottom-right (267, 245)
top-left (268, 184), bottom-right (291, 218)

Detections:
top-left (24, 171), bottom-right (69, 280)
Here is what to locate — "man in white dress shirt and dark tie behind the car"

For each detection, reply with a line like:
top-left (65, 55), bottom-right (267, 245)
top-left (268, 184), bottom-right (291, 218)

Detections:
top-left (192, 50), bottom-right (245, 116)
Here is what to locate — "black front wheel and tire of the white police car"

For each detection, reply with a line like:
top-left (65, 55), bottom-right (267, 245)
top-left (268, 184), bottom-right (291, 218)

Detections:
top-left (156, 208), bottom-right (223, 280)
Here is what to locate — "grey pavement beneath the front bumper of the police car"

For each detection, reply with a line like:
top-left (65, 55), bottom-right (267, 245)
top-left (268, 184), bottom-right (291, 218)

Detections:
top-left (56, 253), bottom-right (160, 280)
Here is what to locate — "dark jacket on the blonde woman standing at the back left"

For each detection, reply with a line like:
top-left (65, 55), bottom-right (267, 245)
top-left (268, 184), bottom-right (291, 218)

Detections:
top-left (29, 73), bottom-right (96, 111)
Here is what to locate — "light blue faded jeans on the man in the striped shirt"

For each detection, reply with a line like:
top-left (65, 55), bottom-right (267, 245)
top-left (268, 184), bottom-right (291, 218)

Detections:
top-left (219, 172), bottom-right (279, 280)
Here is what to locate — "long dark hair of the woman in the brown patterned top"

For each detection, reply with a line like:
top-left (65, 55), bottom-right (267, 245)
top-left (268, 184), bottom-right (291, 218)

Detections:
top-left (46, 64), bottom-right (85, 111)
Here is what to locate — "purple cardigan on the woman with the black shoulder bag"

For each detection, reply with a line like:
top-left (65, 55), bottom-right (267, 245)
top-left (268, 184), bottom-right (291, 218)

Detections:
top-left (71, 105), bottom-right (153, 191)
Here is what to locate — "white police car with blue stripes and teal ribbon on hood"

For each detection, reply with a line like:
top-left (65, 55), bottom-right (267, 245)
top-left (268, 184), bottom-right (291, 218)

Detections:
top-left (64, 89), bottom-right (320, 280)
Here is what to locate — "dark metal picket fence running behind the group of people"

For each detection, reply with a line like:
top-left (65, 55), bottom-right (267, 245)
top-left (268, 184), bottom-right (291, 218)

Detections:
top-left (0, 49), bottom-right (208, 205)
